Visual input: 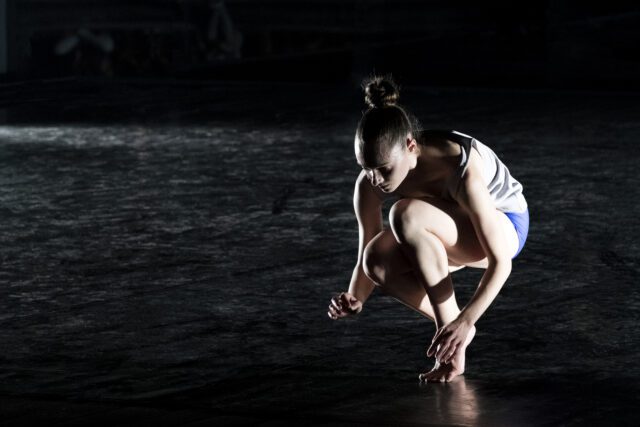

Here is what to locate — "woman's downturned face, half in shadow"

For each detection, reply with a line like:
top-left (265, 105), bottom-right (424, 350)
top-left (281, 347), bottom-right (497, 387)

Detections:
top-left (356, 140), bottom-right (411, 193)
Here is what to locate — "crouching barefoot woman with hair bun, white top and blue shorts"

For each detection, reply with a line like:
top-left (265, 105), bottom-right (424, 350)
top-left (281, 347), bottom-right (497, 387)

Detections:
top-left (328, 76), bottom-right (529, 382)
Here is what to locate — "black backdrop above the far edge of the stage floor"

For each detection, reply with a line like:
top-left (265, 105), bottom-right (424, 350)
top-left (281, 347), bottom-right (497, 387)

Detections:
top-left (4, 0), bottom-right (640, 90)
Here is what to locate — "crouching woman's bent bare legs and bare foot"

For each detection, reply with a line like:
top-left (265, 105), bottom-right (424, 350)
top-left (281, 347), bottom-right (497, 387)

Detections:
top-left (364, 199), bottom-right (485, 382)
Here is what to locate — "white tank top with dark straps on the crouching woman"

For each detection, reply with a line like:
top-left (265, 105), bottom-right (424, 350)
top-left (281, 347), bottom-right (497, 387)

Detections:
top-left (422, 129), bottom-right (528, 213)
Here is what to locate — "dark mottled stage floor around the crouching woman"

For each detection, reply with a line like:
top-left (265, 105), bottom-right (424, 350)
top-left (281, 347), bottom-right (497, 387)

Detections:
top-left (0, 79), bottom-right (640, 426)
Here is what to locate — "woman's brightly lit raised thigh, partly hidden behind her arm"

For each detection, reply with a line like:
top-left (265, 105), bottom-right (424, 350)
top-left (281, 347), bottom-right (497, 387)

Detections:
top-left (390, 198), bottom-right (518, 271)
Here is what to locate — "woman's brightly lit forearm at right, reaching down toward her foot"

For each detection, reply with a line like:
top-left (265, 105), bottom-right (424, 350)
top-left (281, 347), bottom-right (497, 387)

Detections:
top-left (458, 262), bottom-right (511, 325)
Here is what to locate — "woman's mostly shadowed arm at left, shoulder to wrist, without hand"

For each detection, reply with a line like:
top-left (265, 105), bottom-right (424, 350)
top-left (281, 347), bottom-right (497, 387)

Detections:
top-left (349, 170), bottom-right (384, 304)
